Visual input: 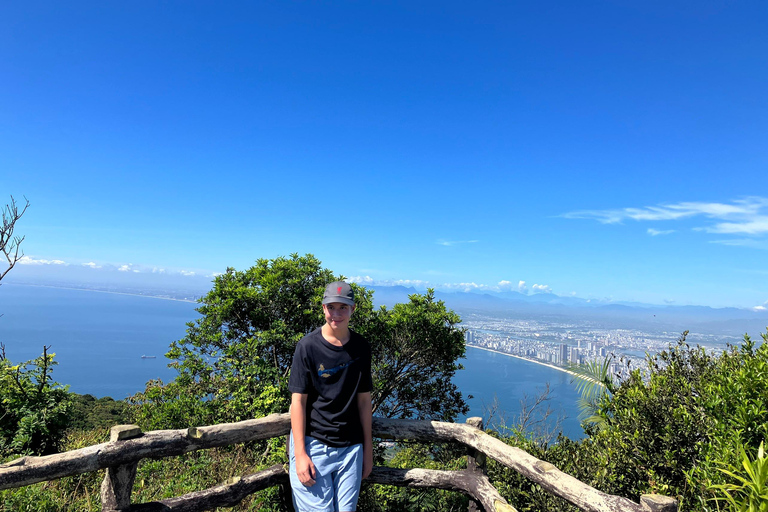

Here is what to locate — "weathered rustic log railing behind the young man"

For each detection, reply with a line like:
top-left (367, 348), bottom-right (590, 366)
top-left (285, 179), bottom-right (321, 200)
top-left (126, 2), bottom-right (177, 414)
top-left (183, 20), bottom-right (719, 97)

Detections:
top-left (0, 414), bottom-right (677, 512)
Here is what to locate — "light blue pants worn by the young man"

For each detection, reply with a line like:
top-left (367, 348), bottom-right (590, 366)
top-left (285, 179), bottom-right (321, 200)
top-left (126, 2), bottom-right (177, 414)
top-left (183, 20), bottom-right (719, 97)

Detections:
top-left (288, 434), bottom-right (363, 512)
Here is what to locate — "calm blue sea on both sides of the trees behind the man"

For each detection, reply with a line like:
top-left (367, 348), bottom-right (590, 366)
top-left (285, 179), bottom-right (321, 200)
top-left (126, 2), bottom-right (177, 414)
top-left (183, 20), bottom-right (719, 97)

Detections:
top-left (0, 283), bottom-right (584, 439)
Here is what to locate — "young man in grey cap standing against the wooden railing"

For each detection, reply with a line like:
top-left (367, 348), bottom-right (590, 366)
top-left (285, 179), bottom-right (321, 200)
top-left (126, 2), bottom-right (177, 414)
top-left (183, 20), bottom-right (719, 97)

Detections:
top-left (288, 281), bottom-right (373, 512)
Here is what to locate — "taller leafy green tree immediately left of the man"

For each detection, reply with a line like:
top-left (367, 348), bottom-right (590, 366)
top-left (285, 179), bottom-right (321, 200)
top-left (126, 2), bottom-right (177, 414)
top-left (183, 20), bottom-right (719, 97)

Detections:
top-left (131, 254), bottom-right (335, 428)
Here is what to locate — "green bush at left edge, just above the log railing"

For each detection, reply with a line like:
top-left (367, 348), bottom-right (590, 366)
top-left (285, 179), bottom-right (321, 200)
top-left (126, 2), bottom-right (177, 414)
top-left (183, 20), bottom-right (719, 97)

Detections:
top-left (0, 344), bottom-right (71, 456)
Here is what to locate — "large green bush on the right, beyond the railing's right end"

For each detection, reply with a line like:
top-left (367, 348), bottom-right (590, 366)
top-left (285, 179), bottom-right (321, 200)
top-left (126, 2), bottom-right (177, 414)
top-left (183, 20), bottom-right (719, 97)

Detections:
top-left (552, 332), bottom-right (768, 511)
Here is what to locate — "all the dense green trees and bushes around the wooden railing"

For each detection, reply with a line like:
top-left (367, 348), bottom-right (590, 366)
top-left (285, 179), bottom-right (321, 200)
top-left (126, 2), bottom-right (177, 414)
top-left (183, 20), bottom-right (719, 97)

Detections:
top-left (0, 255), bottom-right (768, 512)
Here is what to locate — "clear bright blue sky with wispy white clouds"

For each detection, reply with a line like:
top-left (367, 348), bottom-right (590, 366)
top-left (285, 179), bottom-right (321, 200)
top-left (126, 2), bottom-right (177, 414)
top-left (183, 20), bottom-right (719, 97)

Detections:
top-left (0, 0), bottom-right (768, 307)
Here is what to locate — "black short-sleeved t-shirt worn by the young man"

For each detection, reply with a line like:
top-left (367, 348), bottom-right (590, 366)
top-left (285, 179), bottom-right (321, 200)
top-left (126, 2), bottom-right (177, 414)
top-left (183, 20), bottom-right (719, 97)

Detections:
top-left (288, 328), bottom-right (373, 447)
